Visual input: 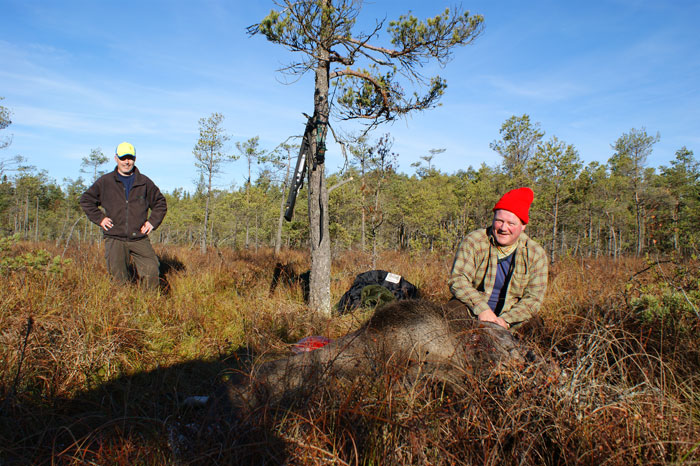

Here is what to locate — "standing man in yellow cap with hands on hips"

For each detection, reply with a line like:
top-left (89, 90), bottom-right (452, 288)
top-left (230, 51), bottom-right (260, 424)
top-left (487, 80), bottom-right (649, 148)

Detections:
top-left (80, 142), bottom-right (168, 289)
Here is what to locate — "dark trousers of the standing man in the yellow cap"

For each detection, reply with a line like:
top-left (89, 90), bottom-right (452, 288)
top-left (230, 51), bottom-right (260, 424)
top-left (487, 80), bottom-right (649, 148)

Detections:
top-left (105, 237), bottom-right (160, 289)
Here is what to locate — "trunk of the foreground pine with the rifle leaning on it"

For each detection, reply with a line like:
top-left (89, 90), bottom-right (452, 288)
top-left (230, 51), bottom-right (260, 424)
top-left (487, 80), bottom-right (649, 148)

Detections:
top-left (306, 32), bottom-right (331, 317)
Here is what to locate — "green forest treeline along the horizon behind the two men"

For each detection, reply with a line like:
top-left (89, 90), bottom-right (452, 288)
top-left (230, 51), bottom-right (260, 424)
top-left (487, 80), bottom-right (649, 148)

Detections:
top-left (0, 114), bottom-right (700, 260)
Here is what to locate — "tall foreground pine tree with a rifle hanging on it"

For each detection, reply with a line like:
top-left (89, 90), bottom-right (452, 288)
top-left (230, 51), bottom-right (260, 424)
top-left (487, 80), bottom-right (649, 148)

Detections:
top-left (248, 0), bottom-right (483, 316)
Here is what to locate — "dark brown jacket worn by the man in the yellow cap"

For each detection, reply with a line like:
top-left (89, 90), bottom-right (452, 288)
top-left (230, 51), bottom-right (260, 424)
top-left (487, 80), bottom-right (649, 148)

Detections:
top-left (80, 167), bottom-right (168, 241)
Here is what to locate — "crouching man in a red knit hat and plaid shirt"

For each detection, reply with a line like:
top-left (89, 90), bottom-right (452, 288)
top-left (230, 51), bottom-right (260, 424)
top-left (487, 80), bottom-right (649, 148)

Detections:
top-left (448, 188), bottom-right (547, 329)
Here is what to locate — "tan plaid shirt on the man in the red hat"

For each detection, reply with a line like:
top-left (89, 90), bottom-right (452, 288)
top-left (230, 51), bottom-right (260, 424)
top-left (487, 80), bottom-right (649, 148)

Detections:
top-left (448, 227), bottom-right (547, 327)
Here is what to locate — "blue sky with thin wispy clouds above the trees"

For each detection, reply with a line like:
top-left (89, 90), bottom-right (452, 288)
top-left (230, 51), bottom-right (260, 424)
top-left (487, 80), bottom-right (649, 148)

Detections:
top-left (0, 0), bottom-right (700, 191)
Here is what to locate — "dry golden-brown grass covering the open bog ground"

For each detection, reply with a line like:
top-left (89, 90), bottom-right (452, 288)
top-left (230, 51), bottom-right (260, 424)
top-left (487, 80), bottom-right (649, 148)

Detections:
top-left (0, 244), bottom-right (700, 465)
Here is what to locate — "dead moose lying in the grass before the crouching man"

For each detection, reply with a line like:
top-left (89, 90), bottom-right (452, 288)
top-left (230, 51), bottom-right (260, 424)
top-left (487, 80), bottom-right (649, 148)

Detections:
top-left (219, 300), bottom-right (534, 409)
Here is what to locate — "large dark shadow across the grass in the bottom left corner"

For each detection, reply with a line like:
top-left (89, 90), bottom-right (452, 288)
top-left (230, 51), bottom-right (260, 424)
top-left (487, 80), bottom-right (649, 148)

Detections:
top-left (0, 348), bottom-right (285, 466)
